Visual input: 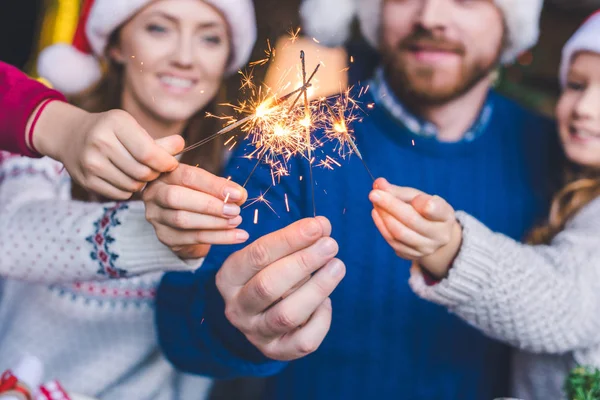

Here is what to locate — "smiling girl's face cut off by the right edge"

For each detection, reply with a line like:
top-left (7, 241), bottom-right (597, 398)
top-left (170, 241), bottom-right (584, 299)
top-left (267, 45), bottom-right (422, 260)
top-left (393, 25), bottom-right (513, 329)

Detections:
top-left (556, 52), bottom-right (600, 168)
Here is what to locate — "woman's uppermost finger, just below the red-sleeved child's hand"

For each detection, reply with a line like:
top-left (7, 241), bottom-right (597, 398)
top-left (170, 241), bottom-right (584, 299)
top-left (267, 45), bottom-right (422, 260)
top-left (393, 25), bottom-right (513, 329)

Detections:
top-left (164, 164), bottom-right (248, 205)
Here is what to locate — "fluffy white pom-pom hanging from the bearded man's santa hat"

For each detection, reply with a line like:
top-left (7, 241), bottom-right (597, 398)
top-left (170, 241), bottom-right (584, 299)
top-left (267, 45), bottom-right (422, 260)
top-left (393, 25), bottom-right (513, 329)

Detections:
top-left (300, 0), bottom-right (356, 47)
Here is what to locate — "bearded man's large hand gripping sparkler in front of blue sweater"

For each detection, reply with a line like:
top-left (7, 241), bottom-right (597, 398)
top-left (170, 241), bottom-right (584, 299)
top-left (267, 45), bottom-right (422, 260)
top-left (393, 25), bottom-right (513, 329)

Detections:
top-left (216, 217), bottom-right (346, 361)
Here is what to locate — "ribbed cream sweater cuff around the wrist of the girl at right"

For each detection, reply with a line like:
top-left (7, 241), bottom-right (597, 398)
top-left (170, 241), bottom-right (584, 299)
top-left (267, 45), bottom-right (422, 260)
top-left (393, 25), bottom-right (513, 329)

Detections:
top-left (409, 212), bottom-right (497, 308)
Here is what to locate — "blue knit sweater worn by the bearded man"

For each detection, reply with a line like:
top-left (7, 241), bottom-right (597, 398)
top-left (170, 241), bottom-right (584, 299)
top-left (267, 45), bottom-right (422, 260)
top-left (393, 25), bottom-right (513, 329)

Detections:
top-left (157, 93), bottom-right (555, 400)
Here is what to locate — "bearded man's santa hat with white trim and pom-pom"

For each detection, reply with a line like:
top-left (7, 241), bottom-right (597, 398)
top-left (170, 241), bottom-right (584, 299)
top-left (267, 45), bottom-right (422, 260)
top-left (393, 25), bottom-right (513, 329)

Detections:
top-left (300, 0), bottom-right (543, 64)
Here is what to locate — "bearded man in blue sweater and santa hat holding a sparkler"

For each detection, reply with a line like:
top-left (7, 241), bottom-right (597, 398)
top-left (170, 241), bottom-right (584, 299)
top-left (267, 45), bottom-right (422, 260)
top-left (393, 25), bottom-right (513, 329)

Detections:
top-left (157, 0), bottom-right (555, 400)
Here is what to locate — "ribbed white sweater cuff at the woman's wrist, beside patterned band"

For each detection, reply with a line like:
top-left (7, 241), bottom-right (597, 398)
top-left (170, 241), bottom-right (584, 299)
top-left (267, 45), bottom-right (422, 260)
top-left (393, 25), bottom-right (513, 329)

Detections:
top-left (113, 201), bottom-right (204, 276)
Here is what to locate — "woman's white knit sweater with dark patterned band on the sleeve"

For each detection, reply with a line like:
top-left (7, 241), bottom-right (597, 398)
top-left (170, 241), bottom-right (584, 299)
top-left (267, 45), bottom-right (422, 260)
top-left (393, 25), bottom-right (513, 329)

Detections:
top-left (0, 153), bottom-right (210, 400)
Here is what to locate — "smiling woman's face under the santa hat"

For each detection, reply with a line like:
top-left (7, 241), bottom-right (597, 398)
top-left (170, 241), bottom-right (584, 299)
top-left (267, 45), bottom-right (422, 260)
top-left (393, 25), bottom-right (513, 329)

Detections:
top-left (110, 0), bottom-right (230, 122)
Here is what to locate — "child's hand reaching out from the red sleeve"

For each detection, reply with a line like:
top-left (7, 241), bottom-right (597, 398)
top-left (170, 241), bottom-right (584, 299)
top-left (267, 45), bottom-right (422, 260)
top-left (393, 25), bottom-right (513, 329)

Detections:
top-left (33, 101), bottom-right (184, 200)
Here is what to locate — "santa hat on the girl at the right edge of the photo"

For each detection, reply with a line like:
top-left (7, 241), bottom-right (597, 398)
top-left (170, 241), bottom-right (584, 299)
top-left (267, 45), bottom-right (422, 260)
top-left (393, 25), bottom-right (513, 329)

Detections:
top-left (559, 10), bottom-right (600, 88)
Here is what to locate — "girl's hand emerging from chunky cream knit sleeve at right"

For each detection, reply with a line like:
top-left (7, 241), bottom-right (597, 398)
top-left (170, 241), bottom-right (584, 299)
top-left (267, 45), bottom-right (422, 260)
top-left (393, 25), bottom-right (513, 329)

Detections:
top-left (369, 179), bottom-right (462, 278)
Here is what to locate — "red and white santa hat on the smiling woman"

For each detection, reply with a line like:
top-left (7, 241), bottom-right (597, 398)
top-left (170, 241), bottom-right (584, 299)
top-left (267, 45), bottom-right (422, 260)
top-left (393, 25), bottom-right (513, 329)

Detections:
top-left (37, 0), bottom-right (256, 94)
